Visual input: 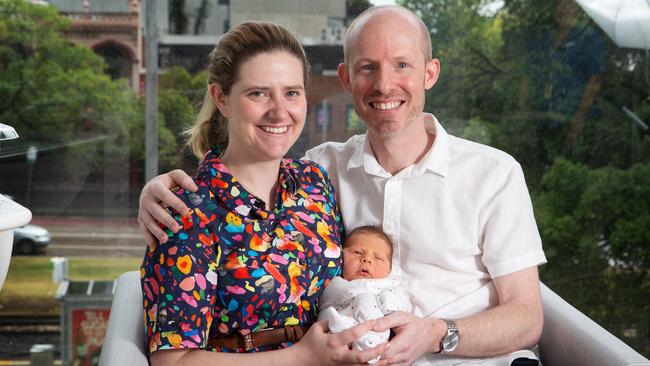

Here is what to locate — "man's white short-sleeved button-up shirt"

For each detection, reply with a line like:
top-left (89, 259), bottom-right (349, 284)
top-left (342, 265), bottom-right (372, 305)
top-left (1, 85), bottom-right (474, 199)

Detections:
top-left (306, 114), bottom-right (546, 318)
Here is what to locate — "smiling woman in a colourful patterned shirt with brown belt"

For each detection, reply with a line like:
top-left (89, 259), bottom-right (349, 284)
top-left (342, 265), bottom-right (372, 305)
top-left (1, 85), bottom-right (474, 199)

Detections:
top-left (141, 22), bottom-right (384, 365)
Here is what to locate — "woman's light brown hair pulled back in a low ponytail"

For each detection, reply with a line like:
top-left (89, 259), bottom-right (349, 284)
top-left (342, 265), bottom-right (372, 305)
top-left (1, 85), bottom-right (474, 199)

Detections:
top-left (185, 21), bottom-right (309, 160)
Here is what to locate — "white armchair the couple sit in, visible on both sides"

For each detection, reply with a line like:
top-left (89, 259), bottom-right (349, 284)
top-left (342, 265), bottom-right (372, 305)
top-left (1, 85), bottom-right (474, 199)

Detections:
top-left (99, 271), bottom-right (650, 366)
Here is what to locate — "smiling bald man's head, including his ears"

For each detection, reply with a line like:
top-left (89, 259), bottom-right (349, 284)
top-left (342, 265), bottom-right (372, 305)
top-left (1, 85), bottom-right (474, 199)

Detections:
top-left (339, 12), bottom-right (440, 137)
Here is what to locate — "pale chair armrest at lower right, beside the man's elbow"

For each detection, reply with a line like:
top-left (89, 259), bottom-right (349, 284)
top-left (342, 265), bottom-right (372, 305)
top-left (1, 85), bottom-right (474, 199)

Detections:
top-left (539, 284), bottom-right (650, 366)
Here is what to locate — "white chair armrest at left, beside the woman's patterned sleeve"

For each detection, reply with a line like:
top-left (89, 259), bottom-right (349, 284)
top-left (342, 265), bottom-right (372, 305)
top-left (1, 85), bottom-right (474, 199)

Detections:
top-left (99, 271), bottom-right (149, 366)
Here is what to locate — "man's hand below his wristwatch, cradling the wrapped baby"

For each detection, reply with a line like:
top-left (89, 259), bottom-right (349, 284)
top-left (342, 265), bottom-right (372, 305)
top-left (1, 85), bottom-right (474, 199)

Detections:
top-left (377, 311), bottom-right (447, 365)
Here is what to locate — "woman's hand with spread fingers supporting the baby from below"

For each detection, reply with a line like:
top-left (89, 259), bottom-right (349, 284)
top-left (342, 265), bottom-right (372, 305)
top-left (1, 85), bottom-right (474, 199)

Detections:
top-left (288, 320), bottom-right (388, 366)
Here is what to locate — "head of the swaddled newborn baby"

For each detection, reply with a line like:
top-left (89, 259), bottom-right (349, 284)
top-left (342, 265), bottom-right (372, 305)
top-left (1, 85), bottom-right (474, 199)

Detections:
top-left (343, 226), bottom-right (393, 281)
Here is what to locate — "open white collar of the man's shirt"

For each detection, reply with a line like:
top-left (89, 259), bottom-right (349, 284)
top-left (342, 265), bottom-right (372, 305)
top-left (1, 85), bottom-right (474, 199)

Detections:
top-left (347, 113), bottom-right (449, 177)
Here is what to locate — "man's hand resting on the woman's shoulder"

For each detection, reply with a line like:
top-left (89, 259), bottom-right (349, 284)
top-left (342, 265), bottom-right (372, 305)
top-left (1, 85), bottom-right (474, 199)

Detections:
top-left (138, 169), bottom-right (199, 243)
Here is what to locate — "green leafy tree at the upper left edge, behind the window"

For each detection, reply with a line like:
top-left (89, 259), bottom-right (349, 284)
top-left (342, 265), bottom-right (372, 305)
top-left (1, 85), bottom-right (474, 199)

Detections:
top-left (0, 0), bottom-right (136, 176)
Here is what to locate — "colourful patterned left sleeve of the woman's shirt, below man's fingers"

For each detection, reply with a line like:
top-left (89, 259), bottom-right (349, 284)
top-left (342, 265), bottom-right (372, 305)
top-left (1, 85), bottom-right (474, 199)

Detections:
top-left (140, 187), bottom-right (218, 352)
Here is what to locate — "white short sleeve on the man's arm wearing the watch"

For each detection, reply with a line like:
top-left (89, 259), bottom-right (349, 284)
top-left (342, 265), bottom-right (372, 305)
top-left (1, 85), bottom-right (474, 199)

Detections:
top-left (480, 163), bottom-right (546, 278)
